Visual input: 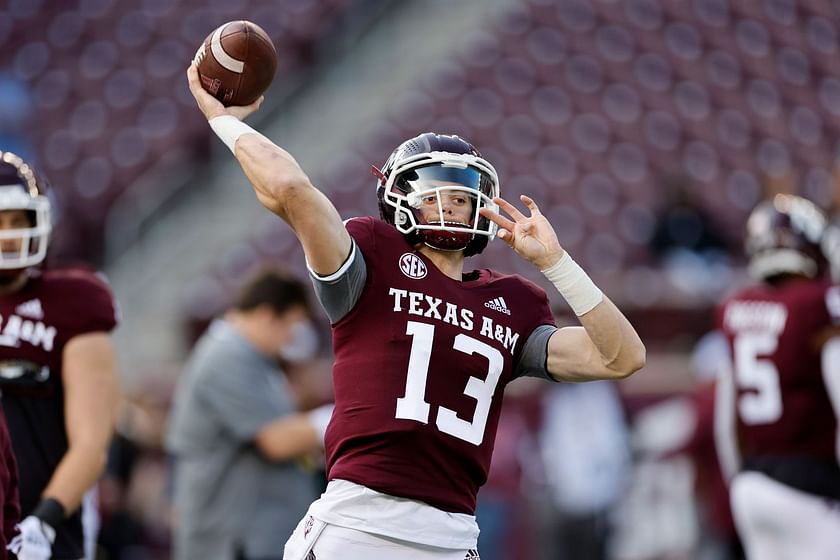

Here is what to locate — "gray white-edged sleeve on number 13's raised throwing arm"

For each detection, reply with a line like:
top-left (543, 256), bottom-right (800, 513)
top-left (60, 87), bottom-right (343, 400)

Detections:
top-left (309, 241), bottom-right (367, 324)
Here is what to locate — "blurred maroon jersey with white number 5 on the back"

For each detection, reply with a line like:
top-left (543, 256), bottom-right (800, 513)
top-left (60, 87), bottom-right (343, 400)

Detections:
top-left (717, 280), bottom-right (840, 464)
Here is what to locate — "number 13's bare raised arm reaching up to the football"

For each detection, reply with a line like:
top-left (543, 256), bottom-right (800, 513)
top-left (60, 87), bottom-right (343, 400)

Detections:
top-left (187, 65), bottom-right (352, 276)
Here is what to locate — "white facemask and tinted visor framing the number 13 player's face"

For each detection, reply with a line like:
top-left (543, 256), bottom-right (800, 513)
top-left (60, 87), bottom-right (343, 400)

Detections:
top-left (381, 152), bottom-right (499, 256)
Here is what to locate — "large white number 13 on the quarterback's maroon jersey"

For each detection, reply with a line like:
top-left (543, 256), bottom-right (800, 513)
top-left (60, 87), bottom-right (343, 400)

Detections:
top-left (397, 321), bottom-right (504, 445)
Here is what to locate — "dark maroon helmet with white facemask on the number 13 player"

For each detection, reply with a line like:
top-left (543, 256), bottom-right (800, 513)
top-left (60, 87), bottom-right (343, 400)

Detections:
top-left (373, 132), bottom-right (499, 257)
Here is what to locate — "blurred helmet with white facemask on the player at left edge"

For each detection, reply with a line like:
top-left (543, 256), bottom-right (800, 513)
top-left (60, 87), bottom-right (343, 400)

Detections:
top-left (0, 151), bottom-right (52, 276)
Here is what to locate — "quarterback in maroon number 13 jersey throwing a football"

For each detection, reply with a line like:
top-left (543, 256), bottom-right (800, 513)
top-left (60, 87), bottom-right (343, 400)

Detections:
top-left (188, 68), bottom-right (645, 560)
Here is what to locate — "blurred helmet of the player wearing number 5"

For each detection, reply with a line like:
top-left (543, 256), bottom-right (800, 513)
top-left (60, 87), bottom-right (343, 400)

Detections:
top-left (745, 194), bottom-right (828, 280)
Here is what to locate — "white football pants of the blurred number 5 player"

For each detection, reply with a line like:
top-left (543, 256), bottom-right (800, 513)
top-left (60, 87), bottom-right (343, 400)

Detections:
top-left (729, 471), bottom-right (840, 560)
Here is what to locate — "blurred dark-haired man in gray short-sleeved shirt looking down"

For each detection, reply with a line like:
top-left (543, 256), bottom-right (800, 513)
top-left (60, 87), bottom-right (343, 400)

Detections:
top-left (166, 270), bottom-right (331, 560)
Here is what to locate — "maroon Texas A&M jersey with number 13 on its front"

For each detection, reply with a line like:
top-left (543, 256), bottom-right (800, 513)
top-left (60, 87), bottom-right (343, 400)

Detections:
top-left (326, 218), bottom-right (554, 513)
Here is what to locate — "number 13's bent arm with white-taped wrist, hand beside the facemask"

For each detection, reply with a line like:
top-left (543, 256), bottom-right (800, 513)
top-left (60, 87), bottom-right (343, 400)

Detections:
top-left (481, 196), bottom-right (645, 381)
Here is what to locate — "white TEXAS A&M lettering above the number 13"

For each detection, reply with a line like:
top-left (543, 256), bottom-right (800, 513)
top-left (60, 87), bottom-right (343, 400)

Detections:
top-left (388, 288), bottom-right (519, 354)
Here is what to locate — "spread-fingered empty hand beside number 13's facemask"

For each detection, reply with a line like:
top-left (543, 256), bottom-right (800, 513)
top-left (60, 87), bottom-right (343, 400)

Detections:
top-left (479, 195), bottom-right (563, 270)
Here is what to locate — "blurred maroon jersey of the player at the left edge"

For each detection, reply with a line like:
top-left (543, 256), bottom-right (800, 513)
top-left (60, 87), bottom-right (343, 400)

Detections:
top-left (0, 270), bottom-right (116, 558)
